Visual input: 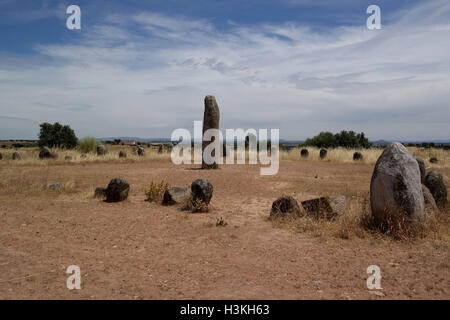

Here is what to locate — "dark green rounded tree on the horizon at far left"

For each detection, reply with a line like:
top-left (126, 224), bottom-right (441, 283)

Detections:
top-left (38, 122), bottom-right (78, 149)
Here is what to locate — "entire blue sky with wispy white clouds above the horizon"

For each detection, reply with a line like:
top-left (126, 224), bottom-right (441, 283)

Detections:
top-left (0, 0), bottom-right (450, 140)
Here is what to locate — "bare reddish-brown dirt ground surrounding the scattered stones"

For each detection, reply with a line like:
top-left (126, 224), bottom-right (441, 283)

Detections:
top-left (0, 160), bottom-right (450, 299)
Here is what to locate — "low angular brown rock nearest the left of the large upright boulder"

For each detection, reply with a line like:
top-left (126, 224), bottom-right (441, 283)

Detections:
top-left (302, 196), bottom-right (346, 220)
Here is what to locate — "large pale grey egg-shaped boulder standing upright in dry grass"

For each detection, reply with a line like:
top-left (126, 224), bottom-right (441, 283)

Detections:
top-left (370, 142), bottom-right (424, 230)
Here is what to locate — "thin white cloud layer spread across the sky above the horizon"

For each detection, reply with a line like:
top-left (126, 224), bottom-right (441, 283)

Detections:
top-left (0, 0), bottom-right (450, 139)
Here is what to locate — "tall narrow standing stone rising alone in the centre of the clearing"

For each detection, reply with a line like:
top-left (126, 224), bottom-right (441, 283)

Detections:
top-left (202, 96), bottom-right (220, 169)
